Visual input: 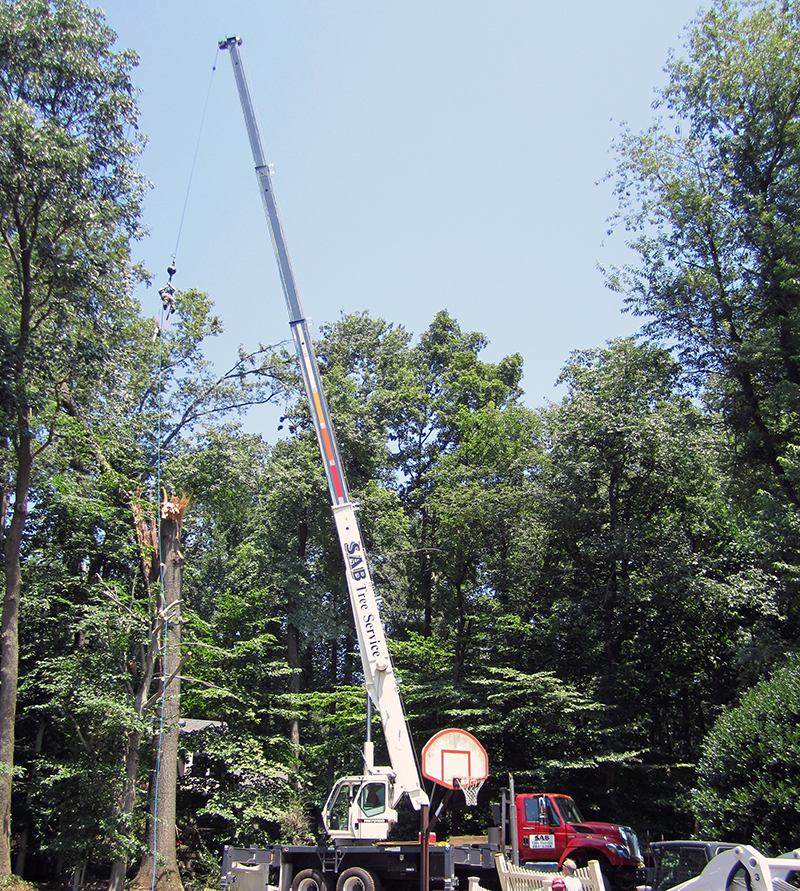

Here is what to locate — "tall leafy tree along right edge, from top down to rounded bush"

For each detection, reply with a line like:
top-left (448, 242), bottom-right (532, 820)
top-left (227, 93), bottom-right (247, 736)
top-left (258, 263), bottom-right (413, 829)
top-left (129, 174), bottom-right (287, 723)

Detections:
top-left (609, 0), bottom-right (800, 832)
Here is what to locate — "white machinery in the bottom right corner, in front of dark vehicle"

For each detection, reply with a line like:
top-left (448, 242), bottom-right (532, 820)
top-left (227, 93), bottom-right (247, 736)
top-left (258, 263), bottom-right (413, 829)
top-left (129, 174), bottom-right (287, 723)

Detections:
top-left (671, 845), bottom-right (800, 891)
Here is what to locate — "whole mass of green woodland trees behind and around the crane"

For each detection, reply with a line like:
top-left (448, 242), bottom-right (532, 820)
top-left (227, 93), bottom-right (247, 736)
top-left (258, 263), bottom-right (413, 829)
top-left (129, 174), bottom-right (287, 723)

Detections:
top-left (0, 0), bottom-right (800, 891)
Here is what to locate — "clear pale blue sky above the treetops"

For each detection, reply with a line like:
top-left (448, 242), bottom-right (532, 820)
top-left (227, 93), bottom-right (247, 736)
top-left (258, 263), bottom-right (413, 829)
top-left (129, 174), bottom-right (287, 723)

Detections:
top-left (100, 0), bottom-right (700, 440)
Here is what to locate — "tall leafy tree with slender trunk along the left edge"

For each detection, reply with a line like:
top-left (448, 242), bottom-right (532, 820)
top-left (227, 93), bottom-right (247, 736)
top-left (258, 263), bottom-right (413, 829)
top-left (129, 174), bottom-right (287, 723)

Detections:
top-left (0, 0), bottom-right (142, 876)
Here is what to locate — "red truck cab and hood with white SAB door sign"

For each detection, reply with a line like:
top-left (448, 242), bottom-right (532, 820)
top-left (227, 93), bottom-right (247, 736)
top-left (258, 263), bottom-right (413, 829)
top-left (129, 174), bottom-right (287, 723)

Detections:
top-left (511, 792), bottom-right (644, 891)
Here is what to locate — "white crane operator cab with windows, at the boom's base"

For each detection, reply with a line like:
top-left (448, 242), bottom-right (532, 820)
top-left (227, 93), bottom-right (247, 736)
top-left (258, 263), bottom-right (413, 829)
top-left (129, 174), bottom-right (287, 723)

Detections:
top-left (322, 774), bottom-right (397, 841)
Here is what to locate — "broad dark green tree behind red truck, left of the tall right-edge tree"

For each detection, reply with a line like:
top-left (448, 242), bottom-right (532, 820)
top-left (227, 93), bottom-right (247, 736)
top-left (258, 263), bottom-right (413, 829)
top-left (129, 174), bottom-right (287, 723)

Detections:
top-left (531, 340), bottom-right (760, 828)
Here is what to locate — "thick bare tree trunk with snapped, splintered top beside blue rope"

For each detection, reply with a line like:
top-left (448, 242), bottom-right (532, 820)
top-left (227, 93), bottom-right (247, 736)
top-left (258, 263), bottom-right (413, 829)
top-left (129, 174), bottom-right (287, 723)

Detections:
top-left (135, 502), bottom-right (183, 891)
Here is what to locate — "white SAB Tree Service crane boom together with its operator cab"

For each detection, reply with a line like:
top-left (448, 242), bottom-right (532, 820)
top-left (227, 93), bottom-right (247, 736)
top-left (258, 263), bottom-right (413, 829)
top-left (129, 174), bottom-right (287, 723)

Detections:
top-left (219, 37), bottom-right (429, 839)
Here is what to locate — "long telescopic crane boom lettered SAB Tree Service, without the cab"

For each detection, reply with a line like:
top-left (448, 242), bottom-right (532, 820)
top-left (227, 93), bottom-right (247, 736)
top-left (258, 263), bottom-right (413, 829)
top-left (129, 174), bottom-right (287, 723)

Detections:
top-left (219, 37), bottom-right (429, 810)
